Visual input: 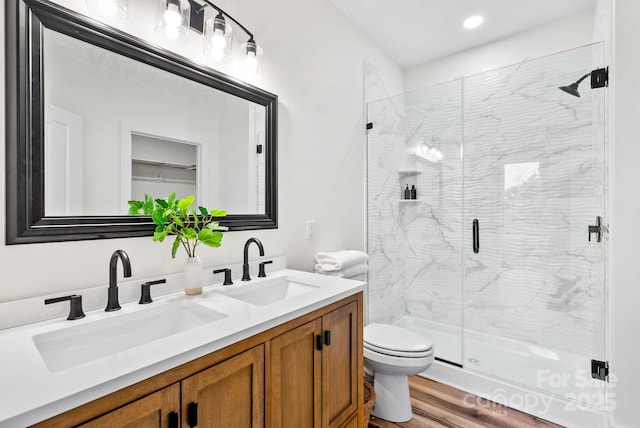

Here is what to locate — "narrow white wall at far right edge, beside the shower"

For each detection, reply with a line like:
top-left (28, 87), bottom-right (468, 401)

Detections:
top-left (610, 0), bottom-right (640, 428)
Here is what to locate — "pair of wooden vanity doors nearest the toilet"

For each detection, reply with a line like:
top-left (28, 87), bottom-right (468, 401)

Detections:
top-left (266, 302), bottom-right (361, 428)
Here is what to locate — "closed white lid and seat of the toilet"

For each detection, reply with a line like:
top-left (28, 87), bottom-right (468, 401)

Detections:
top-left (364, 323), bottom-right (433, 353)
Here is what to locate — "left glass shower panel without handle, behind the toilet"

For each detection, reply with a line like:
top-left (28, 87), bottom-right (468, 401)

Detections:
top-left (367, 80), bottom-right (463, 365)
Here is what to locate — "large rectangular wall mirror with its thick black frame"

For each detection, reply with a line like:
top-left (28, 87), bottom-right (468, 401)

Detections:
top-left (5, 0), bottom-right (278, 244)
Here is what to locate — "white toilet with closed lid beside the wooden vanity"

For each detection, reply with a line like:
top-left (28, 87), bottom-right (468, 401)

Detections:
top-left (364, 323), bottom-right (433, 422)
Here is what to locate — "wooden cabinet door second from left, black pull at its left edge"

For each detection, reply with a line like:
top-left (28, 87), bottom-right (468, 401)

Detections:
top-left (182, 345), bottom-right (264, 428)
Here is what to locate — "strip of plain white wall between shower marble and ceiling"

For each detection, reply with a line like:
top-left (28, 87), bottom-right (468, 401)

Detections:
top-left (405, 10), bottom-right (594, 91)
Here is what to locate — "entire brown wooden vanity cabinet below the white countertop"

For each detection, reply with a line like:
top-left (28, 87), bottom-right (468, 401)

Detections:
top-left (34, 293), bottom-right (364, 428)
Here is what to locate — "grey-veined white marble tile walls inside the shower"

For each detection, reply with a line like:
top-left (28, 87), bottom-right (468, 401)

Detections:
top-left (367, 45), bottom-right (605, 357)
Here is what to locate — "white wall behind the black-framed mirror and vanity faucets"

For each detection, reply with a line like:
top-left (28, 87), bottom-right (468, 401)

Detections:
top-left (0, 0), bottom-right (402, 302)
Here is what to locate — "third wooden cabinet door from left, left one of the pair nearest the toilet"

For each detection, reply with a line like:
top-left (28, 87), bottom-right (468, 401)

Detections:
top-left (266, 319), bottom-right (322, 428)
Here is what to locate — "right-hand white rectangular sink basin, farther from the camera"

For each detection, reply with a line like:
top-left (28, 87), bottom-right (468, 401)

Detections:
top-left (216, 277), bottom-right (319, 306)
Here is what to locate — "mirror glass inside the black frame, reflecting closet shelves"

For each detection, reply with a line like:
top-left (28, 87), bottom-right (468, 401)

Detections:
top-left (43, 29), bottom-right (266, 216)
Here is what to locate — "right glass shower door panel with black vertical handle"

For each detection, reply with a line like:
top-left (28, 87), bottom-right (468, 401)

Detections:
top-left (463, 44), bottom-right (606, 407)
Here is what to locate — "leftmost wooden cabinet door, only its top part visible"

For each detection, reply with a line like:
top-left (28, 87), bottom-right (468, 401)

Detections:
top-left (80, 383), bottom-right (180, 428)
